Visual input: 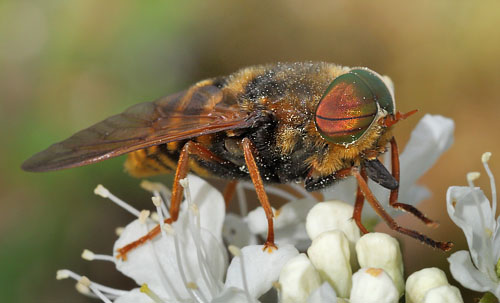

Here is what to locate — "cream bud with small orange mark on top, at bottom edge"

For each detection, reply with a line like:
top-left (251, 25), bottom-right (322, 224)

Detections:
top-left (349, 268), bottom-right (399, 303)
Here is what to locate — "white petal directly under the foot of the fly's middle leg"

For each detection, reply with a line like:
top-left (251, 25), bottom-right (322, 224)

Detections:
top-left (224, 245), bottom-right (299, 298)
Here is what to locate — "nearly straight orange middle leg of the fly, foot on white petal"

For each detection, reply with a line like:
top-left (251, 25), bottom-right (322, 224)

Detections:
top-left (241, 138), bottom-right (277, 251)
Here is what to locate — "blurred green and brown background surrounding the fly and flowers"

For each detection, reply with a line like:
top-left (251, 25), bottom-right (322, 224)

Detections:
top-left (0, 0), bottom-right (500, 302)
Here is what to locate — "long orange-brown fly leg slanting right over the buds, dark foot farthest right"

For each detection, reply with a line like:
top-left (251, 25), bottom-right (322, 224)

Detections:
top-left (352, 168), bottom-right (453, 251)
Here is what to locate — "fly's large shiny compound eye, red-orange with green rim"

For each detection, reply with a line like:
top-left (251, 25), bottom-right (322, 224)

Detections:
top-left (315, 68), bottom-right (394, 145)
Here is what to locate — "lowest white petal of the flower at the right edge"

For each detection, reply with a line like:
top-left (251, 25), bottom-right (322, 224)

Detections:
top-left (448, 250), bottom-right (500, 297)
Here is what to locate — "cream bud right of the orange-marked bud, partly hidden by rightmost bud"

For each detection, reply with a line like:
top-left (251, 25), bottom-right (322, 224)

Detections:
top-left (405, 267), bottom-right (449, 303)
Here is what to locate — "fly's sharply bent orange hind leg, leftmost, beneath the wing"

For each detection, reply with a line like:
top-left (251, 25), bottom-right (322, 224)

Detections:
top-left (117, 141), bottom-right (224, 260)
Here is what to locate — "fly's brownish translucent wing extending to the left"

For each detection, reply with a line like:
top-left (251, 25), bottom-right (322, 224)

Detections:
top-left (22, 85), bottom-right (258, 172)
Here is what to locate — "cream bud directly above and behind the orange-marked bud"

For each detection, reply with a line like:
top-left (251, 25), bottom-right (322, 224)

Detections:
top-left (356, 233), bottom-right (405, 296)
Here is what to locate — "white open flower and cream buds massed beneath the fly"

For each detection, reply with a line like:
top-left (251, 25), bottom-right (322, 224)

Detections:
top-left (58, 176), bottom-right (463, 303)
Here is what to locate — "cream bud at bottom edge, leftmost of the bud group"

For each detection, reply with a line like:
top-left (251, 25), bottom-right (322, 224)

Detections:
top-left (279, 254), bottom-right (321, 303)
